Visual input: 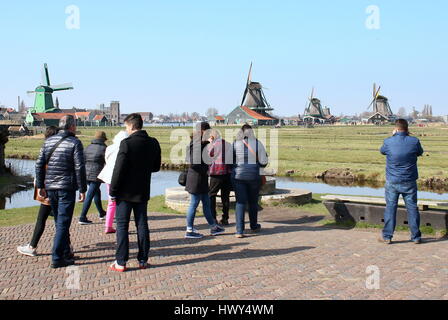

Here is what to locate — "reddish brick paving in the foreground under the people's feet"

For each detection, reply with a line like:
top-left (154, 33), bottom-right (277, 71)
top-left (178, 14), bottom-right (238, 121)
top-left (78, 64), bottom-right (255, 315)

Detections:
top-left (0, 209), bottom-right (448, 299)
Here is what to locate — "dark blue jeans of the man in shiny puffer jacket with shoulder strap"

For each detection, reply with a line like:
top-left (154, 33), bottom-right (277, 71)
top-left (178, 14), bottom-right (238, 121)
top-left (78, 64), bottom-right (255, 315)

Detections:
top-left (48, 190), bottom-right (76, 263)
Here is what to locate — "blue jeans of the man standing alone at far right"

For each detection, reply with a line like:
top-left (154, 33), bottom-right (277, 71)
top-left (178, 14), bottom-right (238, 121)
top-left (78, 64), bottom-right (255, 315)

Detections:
top-left (383, 181), bottom-right (422, 241)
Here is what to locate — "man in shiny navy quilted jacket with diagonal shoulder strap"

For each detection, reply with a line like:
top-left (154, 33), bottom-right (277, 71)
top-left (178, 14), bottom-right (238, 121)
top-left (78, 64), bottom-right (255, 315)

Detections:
top-left (36, 116), bottom-right (87, 268)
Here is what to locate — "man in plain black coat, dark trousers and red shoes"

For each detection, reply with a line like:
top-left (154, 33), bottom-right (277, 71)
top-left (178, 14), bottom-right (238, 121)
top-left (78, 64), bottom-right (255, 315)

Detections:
top-left (110, 113), bottom-right (161, 272)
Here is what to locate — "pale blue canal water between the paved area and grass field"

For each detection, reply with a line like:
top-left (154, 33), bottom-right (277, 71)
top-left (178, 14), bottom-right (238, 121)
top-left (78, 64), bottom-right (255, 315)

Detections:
top-left (0, 159), bottom-right (448, 210)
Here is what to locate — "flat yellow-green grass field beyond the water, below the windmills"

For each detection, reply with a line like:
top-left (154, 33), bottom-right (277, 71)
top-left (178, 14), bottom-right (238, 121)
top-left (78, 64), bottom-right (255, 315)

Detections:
top-left (6, 126), bottom-right (448, 182)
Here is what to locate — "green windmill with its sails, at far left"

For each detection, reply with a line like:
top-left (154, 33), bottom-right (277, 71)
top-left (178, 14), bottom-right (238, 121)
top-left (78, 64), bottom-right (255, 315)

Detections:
top-left (27, 63), bottom-right (73, 113)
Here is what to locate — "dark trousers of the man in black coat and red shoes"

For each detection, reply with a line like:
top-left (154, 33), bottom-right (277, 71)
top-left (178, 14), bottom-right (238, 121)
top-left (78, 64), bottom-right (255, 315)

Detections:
top-left (115, 200), bottom-right (149, 266)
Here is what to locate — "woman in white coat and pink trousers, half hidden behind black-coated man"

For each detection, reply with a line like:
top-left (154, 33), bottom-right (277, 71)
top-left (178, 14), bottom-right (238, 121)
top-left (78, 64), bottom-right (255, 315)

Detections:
top-left (98, 131), bottom-right (129, 234)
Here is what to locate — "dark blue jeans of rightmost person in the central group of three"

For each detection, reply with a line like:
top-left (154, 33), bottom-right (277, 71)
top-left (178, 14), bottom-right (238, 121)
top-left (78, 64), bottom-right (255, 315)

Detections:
top-left (233, 179), bottom-right (260, 234)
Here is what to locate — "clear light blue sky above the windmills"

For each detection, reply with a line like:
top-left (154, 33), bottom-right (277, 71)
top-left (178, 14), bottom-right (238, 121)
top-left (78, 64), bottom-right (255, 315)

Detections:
top-left (0, 0), bottom-right (448, 116)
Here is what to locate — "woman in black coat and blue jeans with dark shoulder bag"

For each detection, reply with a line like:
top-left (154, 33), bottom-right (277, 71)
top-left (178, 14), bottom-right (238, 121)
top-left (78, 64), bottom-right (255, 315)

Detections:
top-left (185, 122), bottom-right (225, 239)
